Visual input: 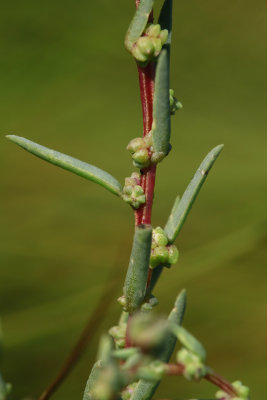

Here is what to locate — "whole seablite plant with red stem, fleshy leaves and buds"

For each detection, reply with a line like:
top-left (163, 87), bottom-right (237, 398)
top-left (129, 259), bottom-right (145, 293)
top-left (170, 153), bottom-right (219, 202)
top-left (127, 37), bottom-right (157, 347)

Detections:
top-left (3, 0), bottom-right (249, 400)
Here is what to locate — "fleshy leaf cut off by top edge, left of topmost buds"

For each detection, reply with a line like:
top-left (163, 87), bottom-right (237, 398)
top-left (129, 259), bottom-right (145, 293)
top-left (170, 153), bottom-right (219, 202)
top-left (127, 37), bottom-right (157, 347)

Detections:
top-left (125, 0), bottom-right (154, 52)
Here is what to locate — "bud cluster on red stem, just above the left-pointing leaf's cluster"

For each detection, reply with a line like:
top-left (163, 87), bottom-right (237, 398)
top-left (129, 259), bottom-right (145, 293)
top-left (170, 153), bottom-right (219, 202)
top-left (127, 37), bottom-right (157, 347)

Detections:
top-left (127, 133), bottom-right (152, 169)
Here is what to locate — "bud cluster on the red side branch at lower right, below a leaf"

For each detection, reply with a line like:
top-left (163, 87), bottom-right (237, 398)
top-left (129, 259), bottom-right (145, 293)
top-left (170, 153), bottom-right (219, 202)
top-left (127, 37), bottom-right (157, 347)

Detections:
top-left (176, 348), bottom-right (207, 381)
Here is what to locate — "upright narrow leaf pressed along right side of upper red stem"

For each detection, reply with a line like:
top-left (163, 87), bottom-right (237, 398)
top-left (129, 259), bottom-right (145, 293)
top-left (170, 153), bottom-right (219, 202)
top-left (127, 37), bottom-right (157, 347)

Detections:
top-left (152, 47), bottom-right (171, 157)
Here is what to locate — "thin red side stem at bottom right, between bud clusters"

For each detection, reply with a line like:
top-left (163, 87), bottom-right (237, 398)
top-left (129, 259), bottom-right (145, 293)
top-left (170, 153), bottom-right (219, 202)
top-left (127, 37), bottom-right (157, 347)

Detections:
top-left (167, 363), bottom-right (240, 397)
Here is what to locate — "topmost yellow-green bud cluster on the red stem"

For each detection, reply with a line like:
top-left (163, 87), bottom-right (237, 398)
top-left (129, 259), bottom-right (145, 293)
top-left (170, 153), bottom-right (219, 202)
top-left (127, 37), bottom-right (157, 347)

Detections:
top-left (132, 24), bottom-right (168, 64)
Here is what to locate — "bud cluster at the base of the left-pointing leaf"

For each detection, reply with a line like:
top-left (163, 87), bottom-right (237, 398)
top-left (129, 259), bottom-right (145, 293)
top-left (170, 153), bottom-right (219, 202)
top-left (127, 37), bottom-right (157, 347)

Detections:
top-left (122, 172), bottom-right (146, 209)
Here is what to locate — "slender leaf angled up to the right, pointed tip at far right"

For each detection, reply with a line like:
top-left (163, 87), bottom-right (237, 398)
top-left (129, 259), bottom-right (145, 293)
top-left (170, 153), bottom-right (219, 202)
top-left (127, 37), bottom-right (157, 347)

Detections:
top-left (164, 144), bottom-right (223, 243)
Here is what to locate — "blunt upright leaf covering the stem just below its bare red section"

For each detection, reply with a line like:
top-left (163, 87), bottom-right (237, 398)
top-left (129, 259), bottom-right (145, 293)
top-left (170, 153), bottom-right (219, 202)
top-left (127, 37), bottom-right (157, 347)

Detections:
top-left (124, 225), bottom-right (152, 312)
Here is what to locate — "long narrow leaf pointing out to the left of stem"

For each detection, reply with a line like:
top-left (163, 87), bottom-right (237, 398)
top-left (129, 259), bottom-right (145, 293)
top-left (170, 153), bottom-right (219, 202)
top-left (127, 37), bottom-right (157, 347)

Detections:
top-left (7, 135), bottom-right (122, 196)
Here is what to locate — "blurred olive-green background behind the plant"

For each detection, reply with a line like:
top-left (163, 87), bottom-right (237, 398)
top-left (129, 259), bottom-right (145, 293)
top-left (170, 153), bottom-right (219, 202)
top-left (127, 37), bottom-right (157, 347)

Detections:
top-left (0, 0), bottom-right (267, 400)
